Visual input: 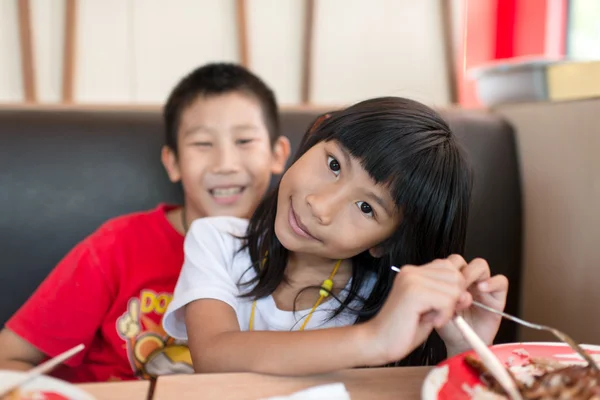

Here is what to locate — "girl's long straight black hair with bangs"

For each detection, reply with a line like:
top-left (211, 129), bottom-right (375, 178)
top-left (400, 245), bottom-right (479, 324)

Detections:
top-left (244, 97), bottom-right (472, 365)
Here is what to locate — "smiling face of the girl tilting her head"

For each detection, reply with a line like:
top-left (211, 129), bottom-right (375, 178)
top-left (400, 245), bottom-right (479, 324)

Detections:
top-left (275, 141), bottom-right (401, 259)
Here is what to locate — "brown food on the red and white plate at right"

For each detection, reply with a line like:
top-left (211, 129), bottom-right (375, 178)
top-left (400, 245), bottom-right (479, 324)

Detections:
top-left (463, 352), bottom-right (600, 400)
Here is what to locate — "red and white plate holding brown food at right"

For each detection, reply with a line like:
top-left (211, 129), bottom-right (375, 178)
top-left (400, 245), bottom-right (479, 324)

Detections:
top-left (421, 342), bottom-right (600, 400)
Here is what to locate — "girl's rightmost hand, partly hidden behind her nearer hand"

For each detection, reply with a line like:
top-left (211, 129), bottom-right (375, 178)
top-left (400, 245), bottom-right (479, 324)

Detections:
top-left (438, 258), bottom-right (508, 356)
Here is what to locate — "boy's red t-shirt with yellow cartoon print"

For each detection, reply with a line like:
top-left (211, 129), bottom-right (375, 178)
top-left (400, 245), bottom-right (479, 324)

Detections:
top-left (6, 204), bottom-right (192, 382)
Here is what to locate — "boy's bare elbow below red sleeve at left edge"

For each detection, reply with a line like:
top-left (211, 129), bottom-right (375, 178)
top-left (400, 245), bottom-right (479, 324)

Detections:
top-left (0, 328), bottom-right (45, 371)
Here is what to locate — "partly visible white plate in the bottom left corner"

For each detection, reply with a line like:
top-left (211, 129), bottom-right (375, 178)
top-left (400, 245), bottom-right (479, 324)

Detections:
top-left (0, 370), bottom-right (94, 400)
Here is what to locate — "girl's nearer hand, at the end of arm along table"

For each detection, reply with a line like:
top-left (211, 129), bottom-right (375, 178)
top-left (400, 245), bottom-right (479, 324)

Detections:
top-left (365, 256), bottom-right (471, 365)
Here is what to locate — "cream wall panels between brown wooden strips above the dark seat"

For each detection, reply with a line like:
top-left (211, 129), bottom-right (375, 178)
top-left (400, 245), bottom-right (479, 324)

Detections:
top-left (0, 0), bottom-right (448, 106)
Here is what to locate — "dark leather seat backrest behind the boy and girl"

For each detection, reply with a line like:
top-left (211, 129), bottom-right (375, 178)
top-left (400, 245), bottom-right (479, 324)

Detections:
top-left (0, 109), bottom-right (521, 341)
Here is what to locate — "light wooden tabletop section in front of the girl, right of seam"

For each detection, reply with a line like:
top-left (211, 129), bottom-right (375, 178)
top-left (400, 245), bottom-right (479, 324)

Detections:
top-left (153, 367), bottom-right (430, 400)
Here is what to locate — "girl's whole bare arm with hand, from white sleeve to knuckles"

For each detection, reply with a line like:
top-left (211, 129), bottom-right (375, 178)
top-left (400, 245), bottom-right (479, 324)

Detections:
top-left (185, 258), bottom-right (470, 375)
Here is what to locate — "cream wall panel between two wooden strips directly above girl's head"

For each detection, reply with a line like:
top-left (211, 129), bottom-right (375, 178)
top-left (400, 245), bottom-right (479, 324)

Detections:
top-left (312, 0), bottom-right (448, 105)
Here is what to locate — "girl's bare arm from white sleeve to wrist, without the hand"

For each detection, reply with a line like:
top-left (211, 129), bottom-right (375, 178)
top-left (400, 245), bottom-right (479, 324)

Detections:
top-left (185, 299), bottom-right (386, 375)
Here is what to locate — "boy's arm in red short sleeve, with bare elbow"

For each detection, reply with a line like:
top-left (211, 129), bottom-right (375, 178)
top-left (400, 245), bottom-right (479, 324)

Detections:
top-left (0, 234), bottom-right (114, 369)
